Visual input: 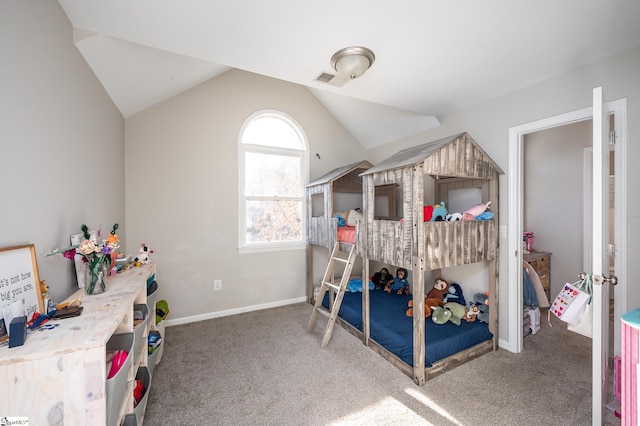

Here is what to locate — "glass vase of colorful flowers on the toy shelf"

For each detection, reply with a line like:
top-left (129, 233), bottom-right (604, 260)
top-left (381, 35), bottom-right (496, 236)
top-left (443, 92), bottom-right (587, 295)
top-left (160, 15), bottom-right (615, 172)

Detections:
top-left (48, 223), bottom-right (120, 294)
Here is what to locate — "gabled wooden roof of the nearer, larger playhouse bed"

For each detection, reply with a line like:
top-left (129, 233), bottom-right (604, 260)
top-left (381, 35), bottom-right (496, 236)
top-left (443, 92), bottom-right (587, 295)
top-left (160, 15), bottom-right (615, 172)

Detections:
top-left (361, 132), bottom-right (504, 179)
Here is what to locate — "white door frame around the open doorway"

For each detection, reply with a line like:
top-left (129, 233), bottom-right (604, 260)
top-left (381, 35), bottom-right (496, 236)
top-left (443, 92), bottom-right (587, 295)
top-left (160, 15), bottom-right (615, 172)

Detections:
top-left (508, 98), bottom-right (628, 354)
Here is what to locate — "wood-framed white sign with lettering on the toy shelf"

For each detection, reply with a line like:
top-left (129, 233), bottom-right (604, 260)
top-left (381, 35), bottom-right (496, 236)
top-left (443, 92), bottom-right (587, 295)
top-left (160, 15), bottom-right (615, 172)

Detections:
top-left (0, 244), bottom-right (44, 329)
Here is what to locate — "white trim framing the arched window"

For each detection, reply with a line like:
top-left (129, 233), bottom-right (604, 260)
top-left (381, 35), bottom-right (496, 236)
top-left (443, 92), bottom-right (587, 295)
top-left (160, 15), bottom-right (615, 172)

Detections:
top-left (237, 109), bottom-right (309, 254)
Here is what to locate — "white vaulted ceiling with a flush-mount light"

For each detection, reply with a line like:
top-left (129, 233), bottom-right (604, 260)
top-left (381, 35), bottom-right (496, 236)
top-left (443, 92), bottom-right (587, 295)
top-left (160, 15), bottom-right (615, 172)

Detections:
top-left (58, 0), bottom-right (640, 149)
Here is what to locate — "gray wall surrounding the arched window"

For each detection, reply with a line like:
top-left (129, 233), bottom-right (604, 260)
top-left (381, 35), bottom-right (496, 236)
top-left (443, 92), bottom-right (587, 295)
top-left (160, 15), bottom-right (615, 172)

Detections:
top-left (126, 70), bottom-right (365, 323)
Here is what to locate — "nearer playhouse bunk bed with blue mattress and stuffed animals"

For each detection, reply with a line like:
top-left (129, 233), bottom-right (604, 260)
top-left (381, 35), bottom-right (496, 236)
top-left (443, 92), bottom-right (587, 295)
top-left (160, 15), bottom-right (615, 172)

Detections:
top-left (308, 133), bottom-right (503, 385)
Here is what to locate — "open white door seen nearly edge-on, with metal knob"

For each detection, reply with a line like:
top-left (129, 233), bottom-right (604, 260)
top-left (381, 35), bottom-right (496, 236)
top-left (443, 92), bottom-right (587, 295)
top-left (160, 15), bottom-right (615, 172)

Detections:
top-left (587, 87), bottom-right (610, 425)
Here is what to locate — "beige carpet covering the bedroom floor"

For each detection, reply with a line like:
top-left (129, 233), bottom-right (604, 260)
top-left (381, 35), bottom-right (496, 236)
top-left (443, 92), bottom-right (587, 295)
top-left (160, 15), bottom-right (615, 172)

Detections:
top-left (144, 304), bottom-right (620, 426)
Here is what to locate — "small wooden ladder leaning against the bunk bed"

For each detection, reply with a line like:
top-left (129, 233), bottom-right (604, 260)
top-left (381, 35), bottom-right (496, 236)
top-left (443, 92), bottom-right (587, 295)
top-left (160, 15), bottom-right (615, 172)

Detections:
top-left (307, 242), bottom-right (356, 348)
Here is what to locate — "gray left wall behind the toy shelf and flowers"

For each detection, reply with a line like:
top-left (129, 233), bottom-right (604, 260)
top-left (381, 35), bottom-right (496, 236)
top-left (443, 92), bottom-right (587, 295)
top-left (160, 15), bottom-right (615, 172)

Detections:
top-left (0, 1), bottom-right (126, 301)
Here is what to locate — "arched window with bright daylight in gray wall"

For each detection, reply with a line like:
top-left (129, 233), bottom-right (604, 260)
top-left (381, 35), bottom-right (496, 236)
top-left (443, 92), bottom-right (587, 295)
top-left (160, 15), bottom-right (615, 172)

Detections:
top-left (238, 111), bottom-right (307, 251)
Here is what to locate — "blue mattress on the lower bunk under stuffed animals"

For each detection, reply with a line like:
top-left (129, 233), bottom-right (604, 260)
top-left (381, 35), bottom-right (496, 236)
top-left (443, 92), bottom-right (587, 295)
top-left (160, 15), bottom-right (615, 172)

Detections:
top-left (323, 290), bottom-right (493, 367)
